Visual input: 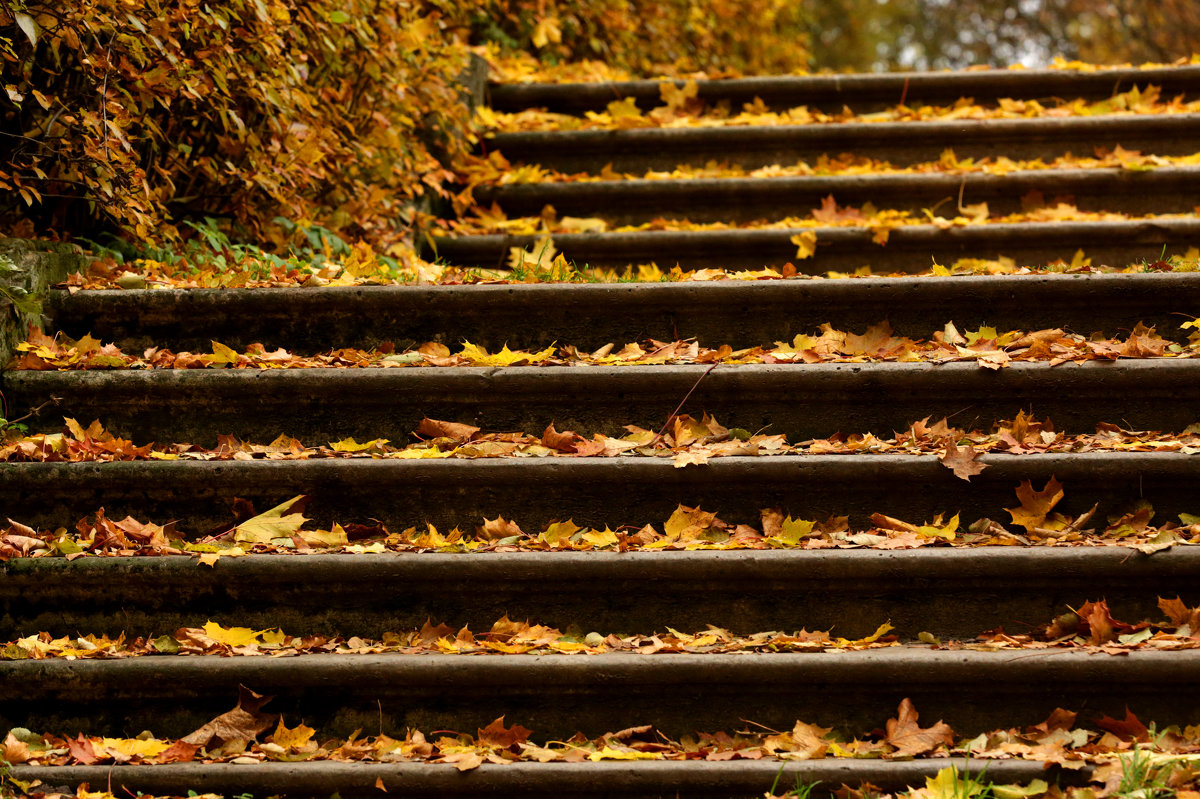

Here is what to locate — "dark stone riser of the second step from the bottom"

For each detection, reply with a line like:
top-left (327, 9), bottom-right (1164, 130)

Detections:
top-left (0, 650), bottom-right (1200, 740)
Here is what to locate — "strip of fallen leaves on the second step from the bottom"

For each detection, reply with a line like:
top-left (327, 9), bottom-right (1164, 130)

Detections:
top-left (7, 597), bottom-right (1200, 660)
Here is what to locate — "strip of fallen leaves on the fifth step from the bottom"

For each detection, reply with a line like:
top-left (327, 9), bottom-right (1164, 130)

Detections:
top-left (8, 320), bottom-right (1200, 371)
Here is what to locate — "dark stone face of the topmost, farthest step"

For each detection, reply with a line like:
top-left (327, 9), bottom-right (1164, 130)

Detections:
top-left (488, 66), bottom-right (1200, 114)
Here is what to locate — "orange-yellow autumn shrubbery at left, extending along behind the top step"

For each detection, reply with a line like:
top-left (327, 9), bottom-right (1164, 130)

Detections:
top-left (0, 0), bottom-right (806, 251)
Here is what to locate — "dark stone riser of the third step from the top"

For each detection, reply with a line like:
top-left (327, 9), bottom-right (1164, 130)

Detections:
top-left (475, 168), bottom-right (1200, 224)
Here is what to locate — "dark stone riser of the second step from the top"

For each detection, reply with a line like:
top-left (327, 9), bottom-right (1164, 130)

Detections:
top-left (482, 114), bottom-right (1200, 174)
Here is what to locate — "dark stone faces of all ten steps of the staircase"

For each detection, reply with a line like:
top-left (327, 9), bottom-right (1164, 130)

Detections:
top-left (0, 67), bottom-right (1200, 797)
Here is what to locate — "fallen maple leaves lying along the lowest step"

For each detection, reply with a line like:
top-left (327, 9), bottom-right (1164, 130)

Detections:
top-left (0, 687), bottom-right (1200, 774)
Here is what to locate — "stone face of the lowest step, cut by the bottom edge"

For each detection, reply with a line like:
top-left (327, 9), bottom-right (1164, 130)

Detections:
top-left (12, 753), bottom-right (1091, 799)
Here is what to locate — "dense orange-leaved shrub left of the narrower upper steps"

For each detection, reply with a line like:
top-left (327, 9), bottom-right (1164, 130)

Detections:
top-left (0, 0), bottom-right (469, 241)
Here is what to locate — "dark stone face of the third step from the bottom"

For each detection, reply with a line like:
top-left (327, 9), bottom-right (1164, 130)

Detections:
top-left (0, 547), bottom-right (1200, 638)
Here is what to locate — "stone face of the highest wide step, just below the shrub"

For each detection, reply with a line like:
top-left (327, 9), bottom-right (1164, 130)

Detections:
top-left (47, 272), bottom-right (1200, 353)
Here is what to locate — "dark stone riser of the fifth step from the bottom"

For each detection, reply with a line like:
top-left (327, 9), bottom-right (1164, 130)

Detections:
top-left (4, 359), bottom-right (1200, 446)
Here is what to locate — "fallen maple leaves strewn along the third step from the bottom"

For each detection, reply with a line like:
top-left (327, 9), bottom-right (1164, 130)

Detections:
top-left (0, 463), bottom-right (1200, 566)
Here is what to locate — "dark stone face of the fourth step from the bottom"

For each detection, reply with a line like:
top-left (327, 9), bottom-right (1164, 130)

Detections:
top-left (0, 451), bottom-right (1200, 537)
